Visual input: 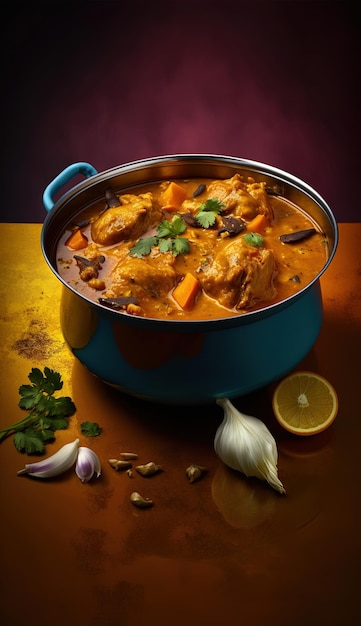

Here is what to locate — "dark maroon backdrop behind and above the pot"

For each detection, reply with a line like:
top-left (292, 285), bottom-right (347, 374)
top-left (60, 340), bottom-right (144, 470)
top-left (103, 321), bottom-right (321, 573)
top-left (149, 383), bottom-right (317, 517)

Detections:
top-left (1, 0), bottom-right (361, 222)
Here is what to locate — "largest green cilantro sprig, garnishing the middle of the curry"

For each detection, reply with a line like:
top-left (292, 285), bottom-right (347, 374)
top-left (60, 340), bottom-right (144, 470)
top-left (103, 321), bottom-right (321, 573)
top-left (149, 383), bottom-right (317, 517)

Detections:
top-left (129, 215), bottom-right (190, 257)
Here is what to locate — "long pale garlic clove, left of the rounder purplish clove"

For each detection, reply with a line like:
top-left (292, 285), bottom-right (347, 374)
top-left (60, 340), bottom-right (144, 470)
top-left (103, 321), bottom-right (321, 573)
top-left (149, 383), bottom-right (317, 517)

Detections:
top-left (17, 439), bottom-right (79, 478)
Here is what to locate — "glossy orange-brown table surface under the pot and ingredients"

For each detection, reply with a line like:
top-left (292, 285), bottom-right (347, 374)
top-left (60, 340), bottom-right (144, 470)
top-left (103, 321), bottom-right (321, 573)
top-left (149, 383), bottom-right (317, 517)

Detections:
top-left (0, 223), bottom-right (361, 626)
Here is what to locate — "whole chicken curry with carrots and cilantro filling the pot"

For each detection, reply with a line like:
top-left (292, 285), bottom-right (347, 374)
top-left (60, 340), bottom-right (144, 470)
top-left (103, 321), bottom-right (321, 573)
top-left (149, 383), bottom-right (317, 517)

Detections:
top-left (57, 174), bottom-right (329, 320)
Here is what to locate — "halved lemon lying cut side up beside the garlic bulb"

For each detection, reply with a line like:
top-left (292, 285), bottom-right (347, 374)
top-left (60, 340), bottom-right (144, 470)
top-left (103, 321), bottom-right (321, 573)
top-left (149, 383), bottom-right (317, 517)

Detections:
top-left (272, 371), bottom-right (338, 435)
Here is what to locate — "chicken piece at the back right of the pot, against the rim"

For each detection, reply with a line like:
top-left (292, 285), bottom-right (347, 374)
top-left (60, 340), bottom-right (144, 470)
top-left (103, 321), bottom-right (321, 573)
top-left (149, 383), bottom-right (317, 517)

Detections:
top-left (208, 174), bottom-right (272, 220)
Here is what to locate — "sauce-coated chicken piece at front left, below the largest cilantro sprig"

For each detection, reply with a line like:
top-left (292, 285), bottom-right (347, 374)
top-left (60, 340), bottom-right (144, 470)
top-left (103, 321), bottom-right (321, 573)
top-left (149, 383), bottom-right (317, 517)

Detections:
top-left (106, 254), bottom-right (177, 306)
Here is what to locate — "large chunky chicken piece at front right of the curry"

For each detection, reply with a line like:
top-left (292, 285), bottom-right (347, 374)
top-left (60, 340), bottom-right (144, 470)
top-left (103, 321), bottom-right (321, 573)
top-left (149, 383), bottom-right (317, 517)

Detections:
top-left (199, 239), bottom-right (276, 310)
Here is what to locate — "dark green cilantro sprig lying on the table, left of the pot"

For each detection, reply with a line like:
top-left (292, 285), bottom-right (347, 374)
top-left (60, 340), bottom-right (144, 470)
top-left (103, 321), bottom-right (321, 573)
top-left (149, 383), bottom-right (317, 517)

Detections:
top-left (0, 367), bottom-right (76, 454)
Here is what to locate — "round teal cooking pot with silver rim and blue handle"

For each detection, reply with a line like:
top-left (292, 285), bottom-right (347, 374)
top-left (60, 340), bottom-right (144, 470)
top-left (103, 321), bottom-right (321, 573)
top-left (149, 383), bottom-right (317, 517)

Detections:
top-left (41, 154), bottom-right (338, 405)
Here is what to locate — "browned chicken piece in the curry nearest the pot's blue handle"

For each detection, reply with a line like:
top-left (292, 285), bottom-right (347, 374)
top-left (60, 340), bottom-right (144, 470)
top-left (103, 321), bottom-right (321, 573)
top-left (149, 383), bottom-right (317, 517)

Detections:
top-left (91, 192), bottom-right (163, 246)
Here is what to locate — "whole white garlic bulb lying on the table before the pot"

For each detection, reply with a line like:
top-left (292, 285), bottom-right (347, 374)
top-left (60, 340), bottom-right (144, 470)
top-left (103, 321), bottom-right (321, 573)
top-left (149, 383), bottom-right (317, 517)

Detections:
top-left (214, 398), bottom-right (286, 494)
